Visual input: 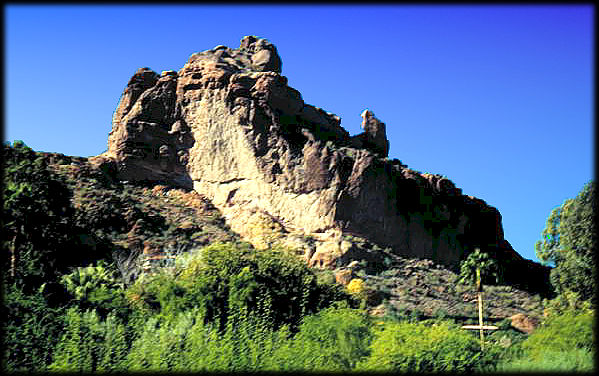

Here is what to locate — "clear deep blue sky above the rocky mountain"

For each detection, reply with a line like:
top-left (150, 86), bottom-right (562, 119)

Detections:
top-left (4, 4), bottom-right (594, 261)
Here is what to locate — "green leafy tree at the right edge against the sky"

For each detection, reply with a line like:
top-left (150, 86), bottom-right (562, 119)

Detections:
top-left (535, 181), bottom-right (597, 305)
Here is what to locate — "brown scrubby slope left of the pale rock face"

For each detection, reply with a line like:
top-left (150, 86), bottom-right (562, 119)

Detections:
top-left (41, 153), bottom-right (240, 284)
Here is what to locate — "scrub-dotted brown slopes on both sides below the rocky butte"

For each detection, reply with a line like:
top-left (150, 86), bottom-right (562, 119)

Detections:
top-left (32, 147), bottom-right (543, 322)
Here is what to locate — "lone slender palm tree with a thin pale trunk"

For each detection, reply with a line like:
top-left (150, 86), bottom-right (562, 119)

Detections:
top-left (458, 248), bottom-right (498, 350)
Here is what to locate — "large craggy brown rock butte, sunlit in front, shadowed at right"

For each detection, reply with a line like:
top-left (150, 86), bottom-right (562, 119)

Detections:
top-left (92, 36), bottom-right (547, 294)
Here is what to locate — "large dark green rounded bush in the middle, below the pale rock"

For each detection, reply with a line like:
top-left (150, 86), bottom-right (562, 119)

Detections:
top-left (127, 243), bottom-right (348, 330)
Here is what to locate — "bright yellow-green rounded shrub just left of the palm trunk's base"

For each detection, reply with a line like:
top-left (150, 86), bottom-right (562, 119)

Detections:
top-left (358, 322), bottom-right (483, 372)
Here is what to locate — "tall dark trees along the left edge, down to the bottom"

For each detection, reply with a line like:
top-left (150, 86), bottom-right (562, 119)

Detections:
top-left (0, 141), bottom-right (73, 372)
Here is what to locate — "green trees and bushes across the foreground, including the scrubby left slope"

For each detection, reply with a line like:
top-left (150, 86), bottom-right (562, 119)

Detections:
top-left (2, 142), bottom-right (595, 372)
